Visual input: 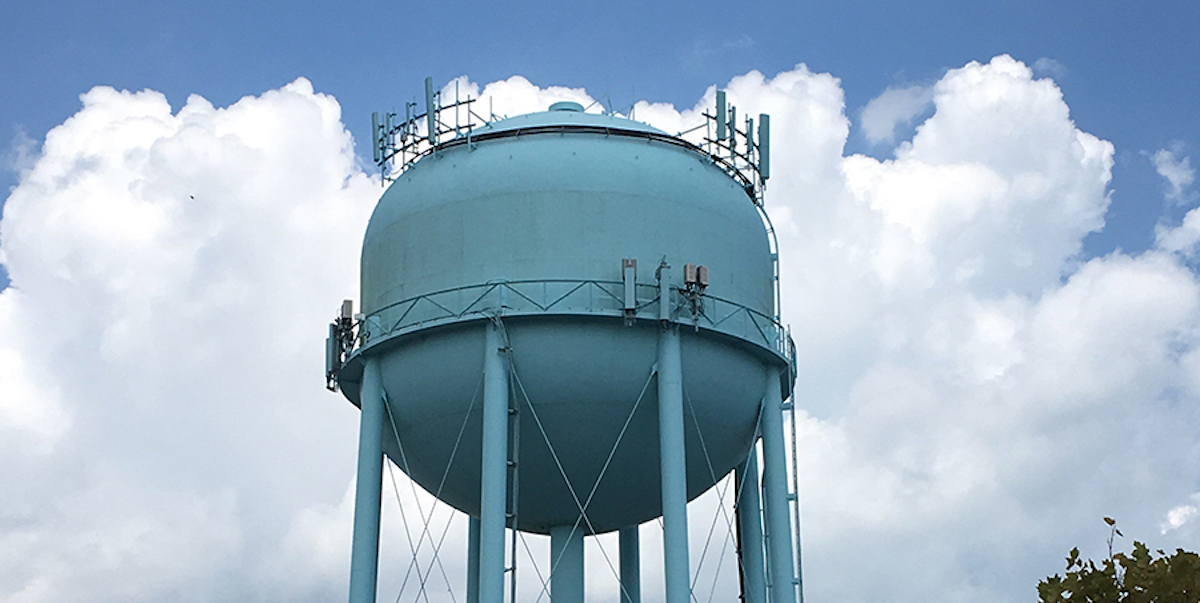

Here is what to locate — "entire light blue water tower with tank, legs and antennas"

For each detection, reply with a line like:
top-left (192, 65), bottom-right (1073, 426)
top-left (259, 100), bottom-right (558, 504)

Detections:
top-left (326, 79), bottom-right (799, 603)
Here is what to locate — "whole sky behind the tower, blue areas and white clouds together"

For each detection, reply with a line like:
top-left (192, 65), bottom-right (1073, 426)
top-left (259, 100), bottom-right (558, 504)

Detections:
top-left (0, 0), bottom-right (1200, 603)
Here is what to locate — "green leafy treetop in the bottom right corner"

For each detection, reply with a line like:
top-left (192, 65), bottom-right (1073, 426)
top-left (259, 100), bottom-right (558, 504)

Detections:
top-left (1038, 518), bottom-right (1200, 603)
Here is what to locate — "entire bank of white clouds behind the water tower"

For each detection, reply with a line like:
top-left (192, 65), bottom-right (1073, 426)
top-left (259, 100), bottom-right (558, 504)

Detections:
top-left (0, 56), bottom-right (1200, 602)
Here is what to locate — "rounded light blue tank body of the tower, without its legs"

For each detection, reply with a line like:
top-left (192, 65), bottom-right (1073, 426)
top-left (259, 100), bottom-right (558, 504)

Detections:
top-left (341, 103), bottom-right (787, 533)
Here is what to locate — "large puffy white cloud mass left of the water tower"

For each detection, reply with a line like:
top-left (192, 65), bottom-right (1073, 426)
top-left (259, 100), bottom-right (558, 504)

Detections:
top-left (0, 79), bottom-right (379, 601)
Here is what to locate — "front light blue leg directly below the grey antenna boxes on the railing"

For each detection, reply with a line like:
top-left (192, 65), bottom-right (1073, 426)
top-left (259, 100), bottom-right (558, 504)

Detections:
top-left (658, 323), bottom-right (691, 603)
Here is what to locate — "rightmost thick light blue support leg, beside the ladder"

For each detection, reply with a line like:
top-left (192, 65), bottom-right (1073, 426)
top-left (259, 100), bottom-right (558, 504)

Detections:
top-left (762, 366), bottom-right (796, 603)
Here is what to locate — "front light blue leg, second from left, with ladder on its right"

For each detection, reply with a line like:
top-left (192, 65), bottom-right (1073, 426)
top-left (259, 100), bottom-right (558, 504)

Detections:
top-left (479, 321), bottom-right (509, 603)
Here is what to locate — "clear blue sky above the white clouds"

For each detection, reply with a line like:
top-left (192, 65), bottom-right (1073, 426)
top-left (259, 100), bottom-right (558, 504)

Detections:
top-left (7, 0), bottom-right (1200, 264)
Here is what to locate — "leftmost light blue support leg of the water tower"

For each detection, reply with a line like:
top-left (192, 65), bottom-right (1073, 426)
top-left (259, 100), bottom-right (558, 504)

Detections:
top-left (349, 357), bottom-right (384, 603)
